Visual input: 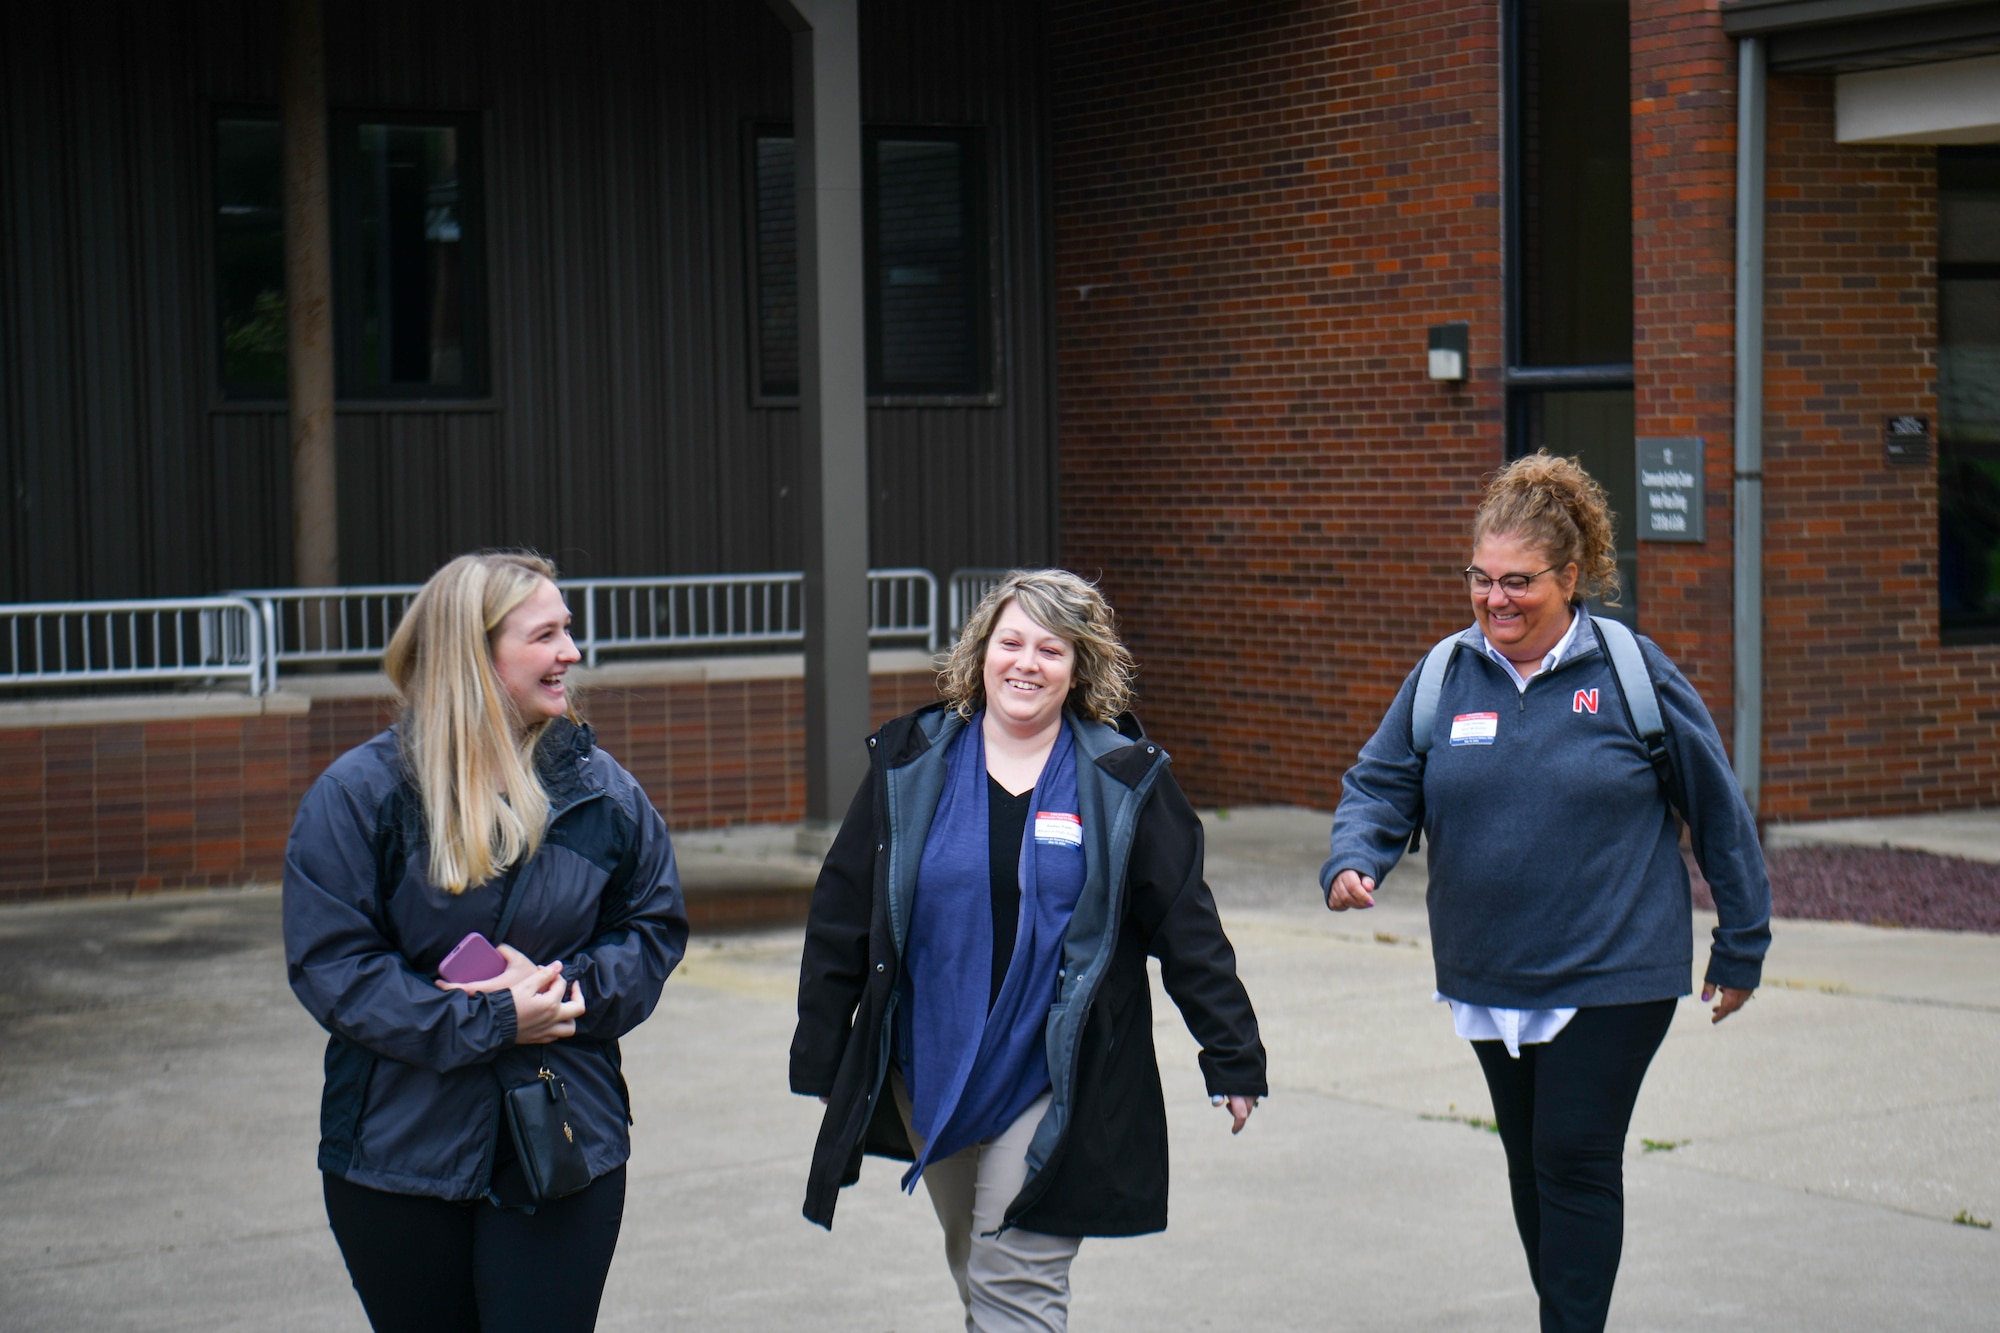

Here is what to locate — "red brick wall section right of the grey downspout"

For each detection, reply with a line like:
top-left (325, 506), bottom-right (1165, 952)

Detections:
top-left (1764, 78), bottom-right (2000, 819)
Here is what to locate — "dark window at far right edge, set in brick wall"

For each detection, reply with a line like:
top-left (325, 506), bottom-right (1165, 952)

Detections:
top-left (1938, 148), bottom-right (2000, 642)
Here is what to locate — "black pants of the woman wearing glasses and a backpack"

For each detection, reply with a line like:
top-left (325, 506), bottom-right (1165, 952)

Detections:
top-left (1472, 1001), bottom-right (1674, 1333)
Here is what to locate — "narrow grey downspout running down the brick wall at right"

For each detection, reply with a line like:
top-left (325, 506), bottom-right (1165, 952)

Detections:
top-left (1732, 38), bottom-right (1766, 815)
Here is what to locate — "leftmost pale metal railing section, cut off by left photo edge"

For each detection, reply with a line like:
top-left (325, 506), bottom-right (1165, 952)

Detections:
top-left (0, 596), bottom-right (268, 695)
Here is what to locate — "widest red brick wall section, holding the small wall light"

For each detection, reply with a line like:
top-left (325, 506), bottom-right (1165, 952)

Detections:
top-left (1050, 0), bottom-right (1502, 807)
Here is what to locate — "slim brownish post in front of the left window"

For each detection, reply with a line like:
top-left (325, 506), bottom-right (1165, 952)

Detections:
top-left (278, 0), bottom-right (340, 588)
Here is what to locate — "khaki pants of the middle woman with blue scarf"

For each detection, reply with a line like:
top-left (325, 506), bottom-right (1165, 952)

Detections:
top-left (890, 1071), bottom-right (1082, 1333)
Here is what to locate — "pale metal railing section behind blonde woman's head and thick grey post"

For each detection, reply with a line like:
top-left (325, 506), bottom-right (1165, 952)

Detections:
top-left (234, 568), bottom-right (940, 689)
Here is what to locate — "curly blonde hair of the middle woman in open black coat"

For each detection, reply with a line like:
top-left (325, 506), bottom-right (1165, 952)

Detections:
top-left (938, 568), bottom-right (1136, 723)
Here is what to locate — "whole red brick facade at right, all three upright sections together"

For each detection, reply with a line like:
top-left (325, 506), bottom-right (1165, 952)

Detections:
top-left (1050, 0), bottom-right (2000, 819)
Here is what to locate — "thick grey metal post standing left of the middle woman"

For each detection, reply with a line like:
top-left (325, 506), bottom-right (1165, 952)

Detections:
top-left (770, 0), bottom-right (870, 829)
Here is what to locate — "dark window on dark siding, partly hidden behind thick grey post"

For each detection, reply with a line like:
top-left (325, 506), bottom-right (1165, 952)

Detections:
top-left (752, 126), bottom-right (992, 398)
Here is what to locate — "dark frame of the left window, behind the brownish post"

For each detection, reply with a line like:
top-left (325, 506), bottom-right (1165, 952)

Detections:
top-left (204, 102), bottom-right (494, 400)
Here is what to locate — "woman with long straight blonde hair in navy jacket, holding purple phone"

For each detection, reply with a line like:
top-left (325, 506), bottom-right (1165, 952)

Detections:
top-left (284, 554), bottom-right (688, 1333)
